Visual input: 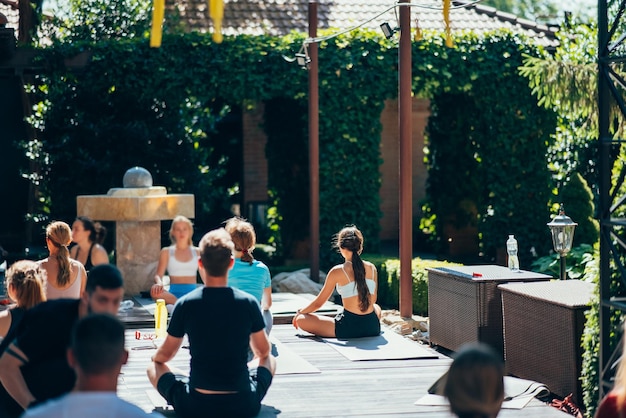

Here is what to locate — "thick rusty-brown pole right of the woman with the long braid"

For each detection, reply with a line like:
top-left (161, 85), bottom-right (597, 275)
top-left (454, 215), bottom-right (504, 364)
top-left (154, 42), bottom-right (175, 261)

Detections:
top-left (398, 0), bottom-right (413, 318)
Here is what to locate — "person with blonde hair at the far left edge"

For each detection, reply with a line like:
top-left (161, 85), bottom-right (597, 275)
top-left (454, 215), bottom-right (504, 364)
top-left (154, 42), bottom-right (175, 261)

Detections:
top-left (0, 260), bottom-right (46, 353)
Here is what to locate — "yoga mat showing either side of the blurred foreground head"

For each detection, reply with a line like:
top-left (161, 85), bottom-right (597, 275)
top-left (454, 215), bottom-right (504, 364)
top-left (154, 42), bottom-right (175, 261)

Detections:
top-left (415, 374), bottom-right (550, 409)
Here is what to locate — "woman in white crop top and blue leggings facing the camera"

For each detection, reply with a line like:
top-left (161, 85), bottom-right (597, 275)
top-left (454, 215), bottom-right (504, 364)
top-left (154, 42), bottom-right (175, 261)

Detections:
top-left (150, 215), bottom-right (200, 305)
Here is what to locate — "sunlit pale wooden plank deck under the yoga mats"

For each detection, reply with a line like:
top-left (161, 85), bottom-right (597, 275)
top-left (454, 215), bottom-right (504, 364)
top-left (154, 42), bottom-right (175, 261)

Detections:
top-left (118, 294), bottom-right (569, 418)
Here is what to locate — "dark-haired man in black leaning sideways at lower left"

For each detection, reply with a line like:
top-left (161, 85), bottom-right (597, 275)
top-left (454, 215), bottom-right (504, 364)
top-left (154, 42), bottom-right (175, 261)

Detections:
top-left (0, 264), bottom-right (124, 418)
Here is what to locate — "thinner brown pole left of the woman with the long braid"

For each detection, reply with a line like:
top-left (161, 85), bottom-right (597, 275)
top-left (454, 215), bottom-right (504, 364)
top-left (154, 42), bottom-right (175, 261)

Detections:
top-left (309, 0), bottom-right (320, 282)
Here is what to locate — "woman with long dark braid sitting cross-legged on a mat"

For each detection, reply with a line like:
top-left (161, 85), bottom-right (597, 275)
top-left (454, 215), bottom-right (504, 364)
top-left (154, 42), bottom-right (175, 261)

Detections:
top-left (292, 226), bottom-right (380, 339)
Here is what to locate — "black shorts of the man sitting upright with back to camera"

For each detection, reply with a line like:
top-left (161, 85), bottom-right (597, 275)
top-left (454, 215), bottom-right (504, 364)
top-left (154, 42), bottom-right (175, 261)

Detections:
top-left (157, 367), bottom-right (272, 418)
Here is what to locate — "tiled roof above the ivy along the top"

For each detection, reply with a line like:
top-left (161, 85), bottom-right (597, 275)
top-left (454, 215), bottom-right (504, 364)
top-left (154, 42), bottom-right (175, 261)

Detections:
top-left (171, 0), bottom-right (557, 46)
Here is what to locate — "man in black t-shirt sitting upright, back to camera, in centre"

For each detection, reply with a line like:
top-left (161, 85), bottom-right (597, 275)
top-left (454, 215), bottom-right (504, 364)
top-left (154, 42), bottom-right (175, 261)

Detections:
top-left (148, 228), bottom-right (276, 418)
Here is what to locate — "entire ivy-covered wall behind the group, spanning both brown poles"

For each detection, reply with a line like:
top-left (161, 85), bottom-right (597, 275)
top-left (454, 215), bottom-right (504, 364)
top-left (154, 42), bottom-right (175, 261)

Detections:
top-left (26, 31), bottom-right (551, 265)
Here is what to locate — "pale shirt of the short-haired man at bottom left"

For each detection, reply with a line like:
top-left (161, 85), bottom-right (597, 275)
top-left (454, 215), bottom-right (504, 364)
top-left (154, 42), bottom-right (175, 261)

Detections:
top-left (22, 392), bottom-right (163, 418)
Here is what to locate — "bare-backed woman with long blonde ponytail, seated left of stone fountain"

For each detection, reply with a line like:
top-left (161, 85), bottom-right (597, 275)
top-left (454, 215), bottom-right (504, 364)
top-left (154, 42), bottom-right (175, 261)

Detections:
top-left (39, 221), bottom-right (87, 300)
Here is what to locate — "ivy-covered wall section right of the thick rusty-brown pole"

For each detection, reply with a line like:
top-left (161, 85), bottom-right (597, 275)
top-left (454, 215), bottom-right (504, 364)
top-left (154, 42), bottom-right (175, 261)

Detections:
top-left (417, 32), bottom-right (556, 262)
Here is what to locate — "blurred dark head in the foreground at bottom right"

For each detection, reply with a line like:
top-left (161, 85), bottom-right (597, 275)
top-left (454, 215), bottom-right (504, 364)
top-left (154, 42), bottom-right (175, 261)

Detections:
top-left (443, 343), bottom-right (504, 418)
